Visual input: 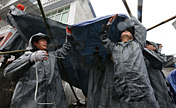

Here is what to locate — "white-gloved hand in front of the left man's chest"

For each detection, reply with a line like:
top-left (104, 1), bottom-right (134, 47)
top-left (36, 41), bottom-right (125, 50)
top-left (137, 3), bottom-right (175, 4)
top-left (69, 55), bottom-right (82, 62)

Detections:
top-left (30, 50), bottom-right (48, 62)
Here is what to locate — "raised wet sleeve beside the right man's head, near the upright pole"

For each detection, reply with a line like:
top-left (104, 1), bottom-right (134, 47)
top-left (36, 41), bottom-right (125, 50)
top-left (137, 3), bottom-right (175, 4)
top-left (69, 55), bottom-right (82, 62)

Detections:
top-left (131, 17), bottom-right (147, 49)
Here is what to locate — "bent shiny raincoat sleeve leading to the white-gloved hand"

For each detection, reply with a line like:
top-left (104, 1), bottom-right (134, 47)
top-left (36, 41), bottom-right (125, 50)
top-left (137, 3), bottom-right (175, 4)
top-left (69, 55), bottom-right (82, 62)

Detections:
top-left (4, 53), bottom-right (34, 80)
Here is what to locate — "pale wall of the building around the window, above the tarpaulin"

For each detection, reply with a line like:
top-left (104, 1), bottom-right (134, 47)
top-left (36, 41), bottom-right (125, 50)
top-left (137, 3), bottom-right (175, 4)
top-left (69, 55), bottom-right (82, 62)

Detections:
top-left (44, 0), bottom-right (95, 25)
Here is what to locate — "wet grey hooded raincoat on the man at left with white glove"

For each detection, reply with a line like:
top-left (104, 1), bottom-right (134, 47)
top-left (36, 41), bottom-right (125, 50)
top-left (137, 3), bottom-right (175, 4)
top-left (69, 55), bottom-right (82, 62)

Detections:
top-left (4, 33), bottom-right (71, 108)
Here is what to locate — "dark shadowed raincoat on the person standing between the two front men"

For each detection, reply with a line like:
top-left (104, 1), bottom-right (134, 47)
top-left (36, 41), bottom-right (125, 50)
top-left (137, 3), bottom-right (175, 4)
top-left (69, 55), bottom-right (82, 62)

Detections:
top-left (87, 53), bottom-right (114, 108)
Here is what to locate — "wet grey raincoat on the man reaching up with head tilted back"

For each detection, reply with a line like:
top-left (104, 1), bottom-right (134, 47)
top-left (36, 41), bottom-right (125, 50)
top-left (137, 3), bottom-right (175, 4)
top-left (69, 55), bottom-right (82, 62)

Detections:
top-left (100, 17), bottom-right (159, 108)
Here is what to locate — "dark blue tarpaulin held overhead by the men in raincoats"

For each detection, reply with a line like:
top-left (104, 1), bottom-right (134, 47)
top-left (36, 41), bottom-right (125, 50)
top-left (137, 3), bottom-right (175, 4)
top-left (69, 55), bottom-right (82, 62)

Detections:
top-left (7, 7), bottom-right (127, 95)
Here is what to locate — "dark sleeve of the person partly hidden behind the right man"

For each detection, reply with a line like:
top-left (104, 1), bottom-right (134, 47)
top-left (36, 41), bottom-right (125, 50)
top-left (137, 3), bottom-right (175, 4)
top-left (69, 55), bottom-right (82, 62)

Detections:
top-left (143, 48), bottom-right (166, 70)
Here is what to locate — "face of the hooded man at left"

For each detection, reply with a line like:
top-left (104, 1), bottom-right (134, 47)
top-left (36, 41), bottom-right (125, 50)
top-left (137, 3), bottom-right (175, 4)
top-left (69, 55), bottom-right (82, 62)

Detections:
top-left (34, 39), bottom-right (48, 50)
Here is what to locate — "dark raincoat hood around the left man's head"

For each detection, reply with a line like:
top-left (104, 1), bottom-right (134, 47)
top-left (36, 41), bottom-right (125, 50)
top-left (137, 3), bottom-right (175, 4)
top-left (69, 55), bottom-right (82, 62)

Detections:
top-left (27, 33), bottom-right (50, 51)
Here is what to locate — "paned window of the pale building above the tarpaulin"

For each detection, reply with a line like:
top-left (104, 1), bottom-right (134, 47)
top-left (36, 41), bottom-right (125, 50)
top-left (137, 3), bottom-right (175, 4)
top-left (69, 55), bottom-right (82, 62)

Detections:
top-left (46, 7), bottom-right (70, 24)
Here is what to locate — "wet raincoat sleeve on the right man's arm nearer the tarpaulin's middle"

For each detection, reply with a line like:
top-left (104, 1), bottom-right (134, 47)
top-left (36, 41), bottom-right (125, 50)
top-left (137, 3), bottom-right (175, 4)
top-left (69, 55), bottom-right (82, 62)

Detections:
top-left (99, 30), bottom-right (115, 54)
